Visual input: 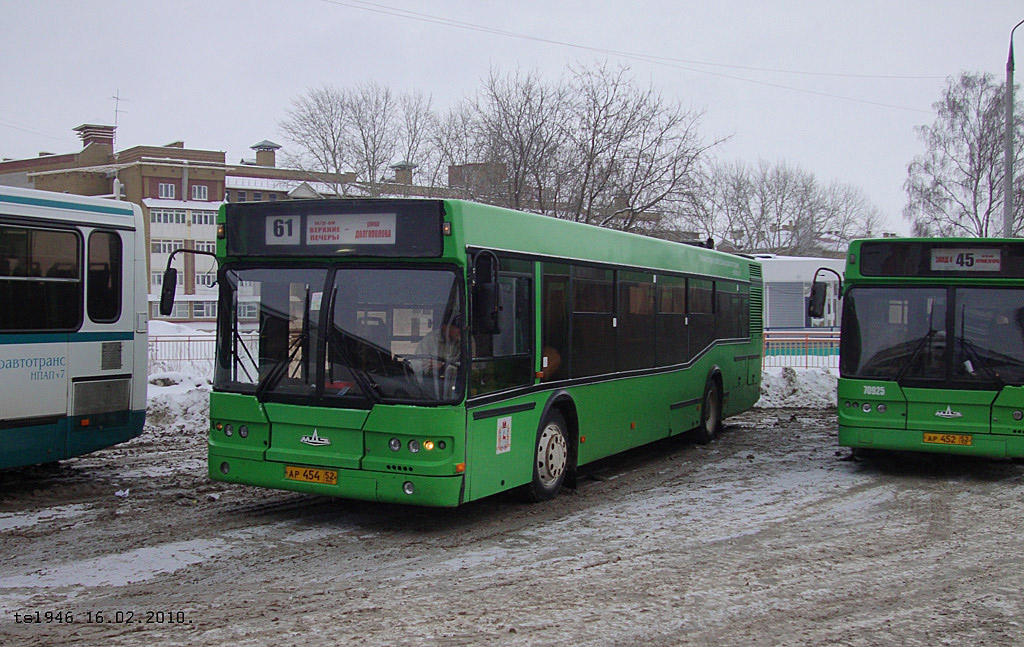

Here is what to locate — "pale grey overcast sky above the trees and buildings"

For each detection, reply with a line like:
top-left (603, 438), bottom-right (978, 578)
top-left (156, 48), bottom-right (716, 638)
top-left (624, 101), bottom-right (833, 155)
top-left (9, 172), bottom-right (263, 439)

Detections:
top-left (0, 0), bottom-right (1024, 232)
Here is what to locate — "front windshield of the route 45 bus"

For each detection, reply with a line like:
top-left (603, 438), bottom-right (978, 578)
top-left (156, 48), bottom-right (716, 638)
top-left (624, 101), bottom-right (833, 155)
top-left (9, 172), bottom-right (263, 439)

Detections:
top-left (840, 287), bottom-right (1024, 388)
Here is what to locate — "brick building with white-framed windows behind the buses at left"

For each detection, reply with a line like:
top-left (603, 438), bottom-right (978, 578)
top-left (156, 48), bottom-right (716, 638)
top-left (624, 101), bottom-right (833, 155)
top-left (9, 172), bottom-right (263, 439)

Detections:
top-left (0, 124), bottom-right (355, 320)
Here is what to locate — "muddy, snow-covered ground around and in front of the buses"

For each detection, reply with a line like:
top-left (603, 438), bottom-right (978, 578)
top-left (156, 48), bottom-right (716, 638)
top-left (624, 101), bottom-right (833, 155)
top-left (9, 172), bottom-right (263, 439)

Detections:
top-left (0, 370), bottom-right (1024, 647)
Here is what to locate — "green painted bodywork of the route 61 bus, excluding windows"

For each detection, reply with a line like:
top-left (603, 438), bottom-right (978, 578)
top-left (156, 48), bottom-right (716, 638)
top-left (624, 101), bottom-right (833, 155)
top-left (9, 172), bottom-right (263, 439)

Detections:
top-left (209, 201), bottom-right (763, 507)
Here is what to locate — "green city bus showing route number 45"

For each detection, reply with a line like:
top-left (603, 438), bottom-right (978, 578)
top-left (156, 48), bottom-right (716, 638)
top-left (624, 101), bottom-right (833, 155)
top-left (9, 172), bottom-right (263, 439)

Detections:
top-left (811, 239), bottom-right (1024, 457)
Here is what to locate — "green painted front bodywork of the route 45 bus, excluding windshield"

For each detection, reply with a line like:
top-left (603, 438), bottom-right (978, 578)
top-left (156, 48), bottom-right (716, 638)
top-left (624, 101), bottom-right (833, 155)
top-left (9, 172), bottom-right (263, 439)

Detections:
top-left (837, 239), bottom-right (1024, 458)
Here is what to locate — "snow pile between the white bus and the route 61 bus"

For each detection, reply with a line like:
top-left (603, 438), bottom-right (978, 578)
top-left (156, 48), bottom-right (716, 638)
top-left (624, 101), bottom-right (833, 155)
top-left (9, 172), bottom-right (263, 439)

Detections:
top-left (145, 371), bottom-right (211, 435)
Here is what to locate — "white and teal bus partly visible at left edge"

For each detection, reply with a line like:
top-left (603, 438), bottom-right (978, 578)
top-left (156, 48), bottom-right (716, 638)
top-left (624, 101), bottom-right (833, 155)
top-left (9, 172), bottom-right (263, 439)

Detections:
top-left (0, 186), bottom-right (146, 468)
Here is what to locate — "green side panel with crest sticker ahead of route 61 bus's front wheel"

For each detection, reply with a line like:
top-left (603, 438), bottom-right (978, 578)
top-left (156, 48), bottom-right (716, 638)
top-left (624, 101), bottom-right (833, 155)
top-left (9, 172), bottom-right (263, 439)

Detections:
top-left (466, 393), bottom-right (548, 500)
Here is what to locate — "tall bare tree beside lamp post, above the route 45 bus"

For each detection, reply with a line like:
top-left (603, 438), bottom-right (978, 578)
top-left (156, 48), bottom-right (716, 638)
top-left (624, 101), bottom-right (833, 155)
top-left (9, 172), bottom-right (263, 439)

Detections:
top-left (903, 73), bottom-right (1024, 236)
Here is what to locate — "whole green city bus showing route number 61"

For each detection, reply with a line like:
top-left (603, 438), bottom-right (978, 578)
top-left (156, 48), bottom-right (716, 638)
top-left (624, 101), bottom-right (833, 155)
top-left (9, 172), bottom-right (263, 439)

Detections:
top-left (165, 199), bottom-right (763, 506)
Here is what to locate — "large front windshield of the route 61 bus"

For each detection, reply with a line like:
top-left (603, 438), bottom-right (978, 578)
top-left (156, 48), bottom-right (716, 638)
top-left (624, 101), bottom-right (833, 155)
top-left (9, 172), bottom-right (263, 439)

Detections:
top-left (220, 265), bottom-right (464, 408)
